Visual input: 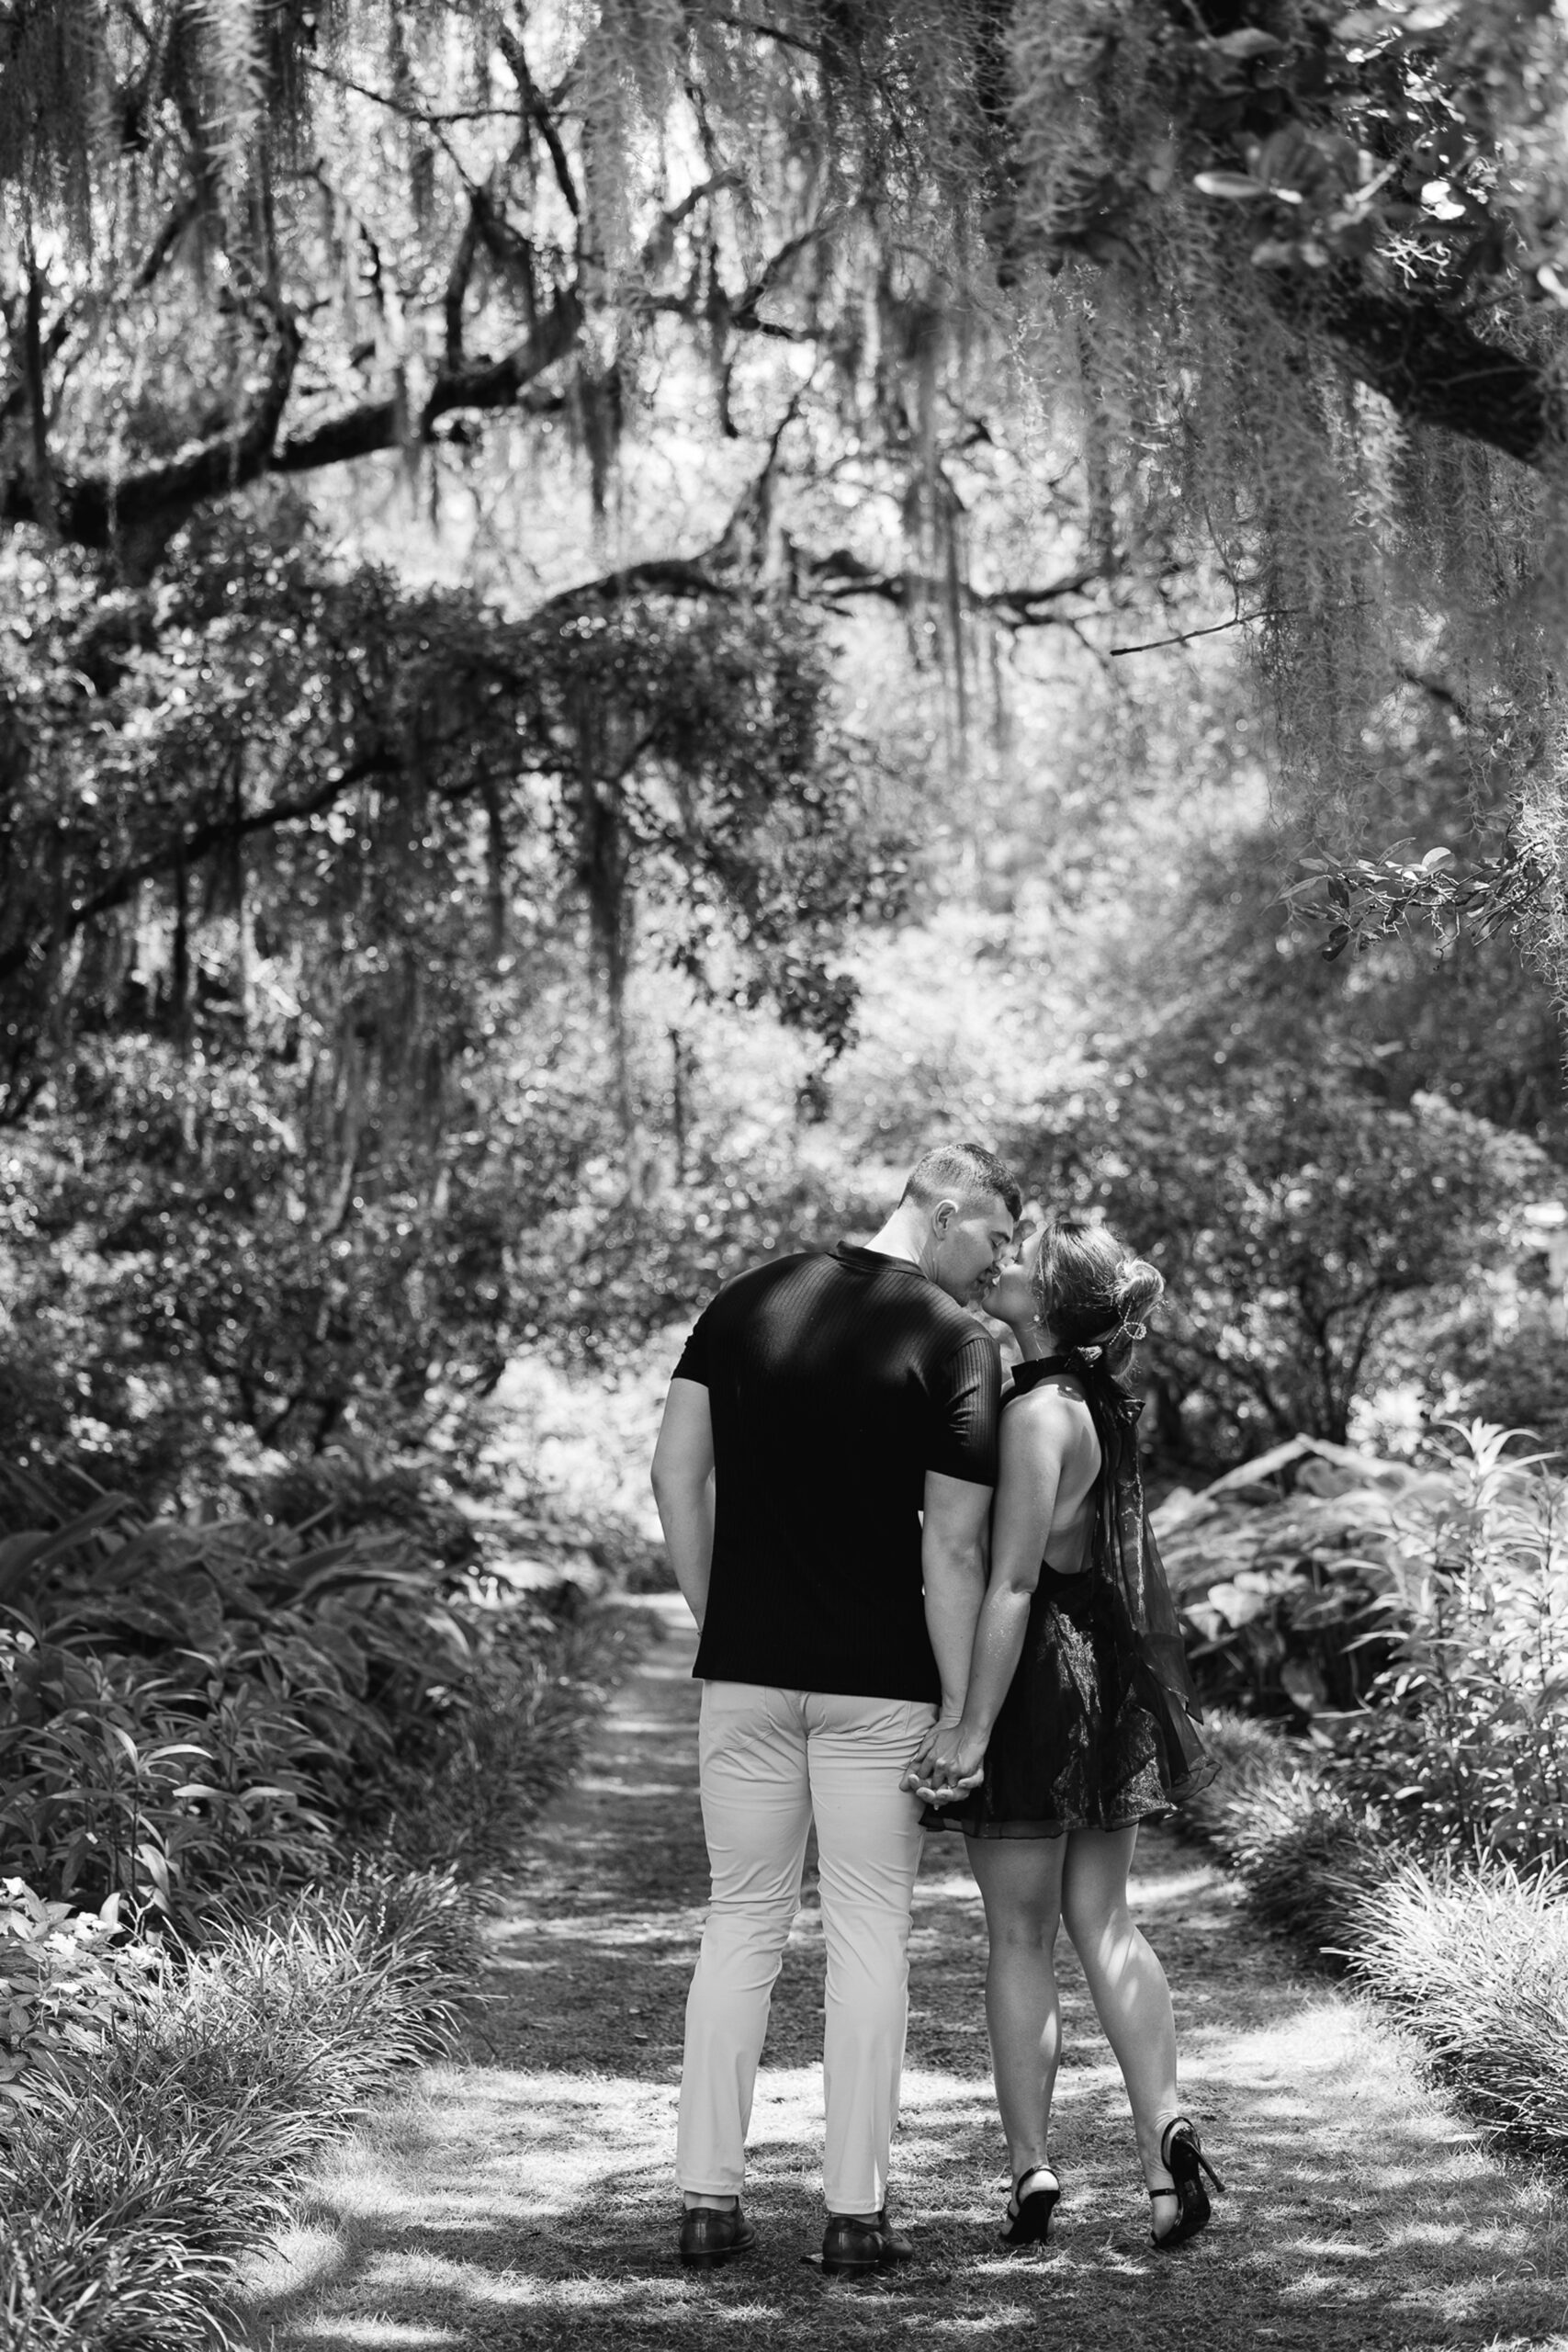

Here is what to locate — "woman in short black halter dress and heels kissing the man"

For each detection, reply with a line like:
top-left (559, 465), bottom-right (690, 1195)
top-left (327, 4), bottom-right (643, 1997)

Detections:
top-left (909, 1218), bottom-right (1220, 2248)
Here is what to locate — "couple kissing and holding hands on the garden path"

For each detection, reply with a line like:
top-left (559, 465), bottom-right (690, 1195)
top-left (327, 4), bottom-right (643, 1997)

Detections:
top-left (653, 1143), bottom-right (1220, 2275)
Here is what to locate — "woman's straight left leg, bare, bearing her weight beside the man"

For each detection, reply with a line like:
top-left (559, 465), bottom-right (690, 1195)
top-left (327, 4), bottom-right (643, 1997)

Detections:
top-left (964, 1837), bottom-right (1067, 2180)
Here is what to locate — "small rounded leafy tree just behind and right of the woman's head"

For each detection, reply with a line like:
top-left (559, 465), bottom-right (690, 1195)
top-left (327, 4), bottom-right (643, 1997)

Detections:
top-left (1034, 1066), bottom-right (1542, 1458)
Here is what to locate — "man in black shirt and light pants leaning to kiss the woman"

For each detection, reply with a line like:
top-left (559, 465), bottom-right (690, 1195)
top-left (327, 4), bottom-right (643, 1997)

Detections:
top-left (653, 1143), bottom-right (1021, 2269)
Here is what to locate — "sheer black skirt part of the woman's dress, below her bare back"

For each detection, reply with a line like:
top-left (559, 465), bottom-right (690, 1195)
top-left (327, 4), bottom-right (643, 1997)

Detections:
top-left (921, 1566), bottom-right (1190, 1837)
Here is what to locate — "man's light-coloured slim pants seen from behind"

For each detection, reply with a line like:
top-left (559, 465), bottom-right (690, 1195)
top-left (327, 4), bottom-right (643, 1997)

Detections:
top-left (674, 1681), bottom-right (936, 2213)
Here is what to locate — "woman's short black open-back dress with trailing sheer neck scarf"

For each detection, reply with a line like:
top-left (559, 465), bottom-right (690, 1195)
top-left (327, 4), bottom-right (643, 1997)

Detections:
top-left (921, 1357), bottom-right (1215, 1837)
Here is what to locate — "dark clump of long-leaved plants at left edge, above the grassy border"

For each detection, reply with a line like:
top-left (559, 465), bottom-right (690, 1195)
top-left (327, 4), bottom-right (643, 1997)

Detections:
top-left (0, 1496), bottom-right (472, 1924)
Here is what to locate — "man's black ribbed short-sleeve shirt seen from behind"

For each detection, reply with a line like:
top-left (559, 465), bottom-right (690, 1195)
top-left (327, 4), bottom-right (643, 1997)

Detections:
top-left (674, 1242), bottom-right (1001, 1701)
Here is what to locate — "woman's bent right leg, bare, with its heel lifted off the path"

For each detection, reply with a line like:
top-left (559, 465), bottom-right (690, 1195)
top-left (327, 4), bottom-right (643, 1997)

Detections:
top-left (1063, 1827), bottom-right (1182, 2234)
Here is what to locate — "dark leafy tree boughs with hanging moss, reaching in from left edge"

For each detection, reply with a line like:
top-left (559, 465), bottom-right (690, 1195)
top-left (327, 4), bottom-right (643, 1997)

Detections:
top-left (0, 505), bottom-right (903, 1110)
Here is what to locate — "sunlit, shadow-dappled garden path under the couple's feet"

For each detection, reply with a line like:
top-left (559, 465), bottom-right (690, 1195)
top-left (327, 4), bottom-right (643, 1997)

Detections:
top-left (252, 1601), bottom-right (1568, 2352)
